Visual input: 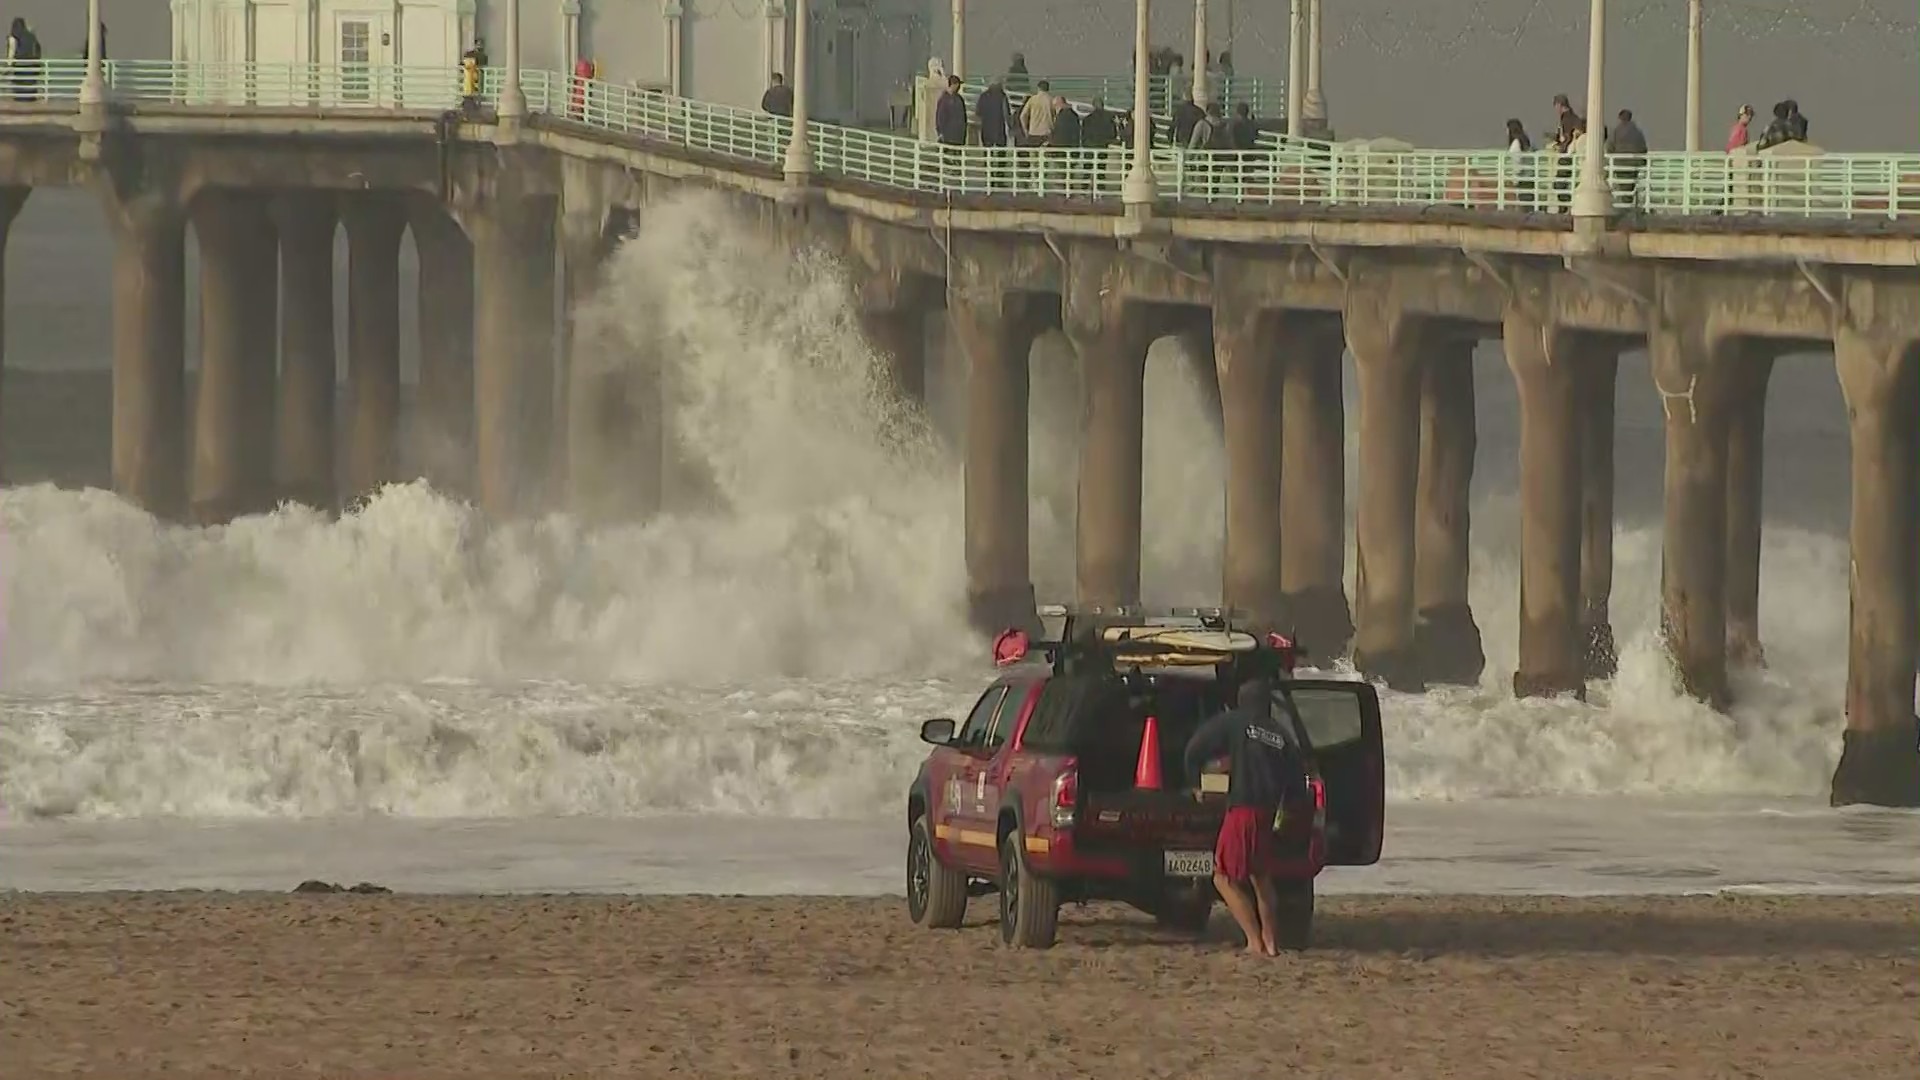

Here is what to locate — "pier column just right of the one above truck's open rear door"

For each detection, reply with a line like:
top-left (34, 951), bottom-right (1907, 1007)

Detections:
top-left (1413, 336), bottom-right (1486, 686)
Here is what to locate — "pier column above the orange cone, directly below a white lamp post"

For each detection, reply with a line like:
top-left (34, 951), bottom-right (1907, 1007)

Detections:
top-left (1066, 296), bottom-right (1160, 605)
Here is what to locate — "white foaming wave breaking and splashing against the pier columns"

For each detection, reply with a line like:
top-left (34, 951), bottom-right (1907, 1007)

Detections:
top-left (0, 198), bottom-right (1847, 817)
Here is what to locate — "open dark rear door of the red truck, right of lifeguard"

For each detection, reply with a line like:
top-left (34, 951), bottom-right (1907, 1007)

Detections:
top-left (1275, 678), bottom-right (1386, 867)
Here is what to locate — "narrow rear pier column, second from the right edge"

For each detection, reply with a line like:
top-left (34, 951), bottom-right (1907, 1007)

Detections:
top-left (1726, 340), bottom-right (1774, 667)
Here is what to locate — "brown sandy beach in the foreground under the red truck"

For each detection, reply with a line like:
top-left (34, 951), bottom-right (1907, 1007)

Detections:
top-left (0, 894), bottom-right (1920, 1080)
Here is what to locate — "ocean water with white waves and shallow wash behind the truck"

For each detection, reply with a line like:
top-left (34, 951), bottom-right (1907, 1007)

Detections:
top-left (0, 198), bottom-right (1920, 894)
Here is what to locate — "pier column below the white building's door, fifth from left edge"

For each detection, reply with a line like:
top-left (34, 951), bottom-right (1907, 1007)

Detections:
top-left (342, 196), bottom-right (407, 502)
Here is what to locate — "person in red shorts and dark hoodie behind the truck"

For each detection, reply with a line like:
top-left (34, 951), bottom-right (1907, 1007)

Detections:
top-left (1185, 678), bottom-right (1302, 957)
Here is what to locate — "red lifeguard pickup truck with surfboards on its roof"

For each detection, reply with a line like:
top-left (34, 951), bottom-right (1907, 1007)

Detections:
top-left (906, 607), bottom-right (1386, 949)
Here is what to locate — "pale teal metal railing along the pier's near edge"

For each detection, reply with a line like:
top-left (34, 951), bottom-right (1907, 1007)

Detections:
top-left (0, 60), bottom-right (1920, 221)
